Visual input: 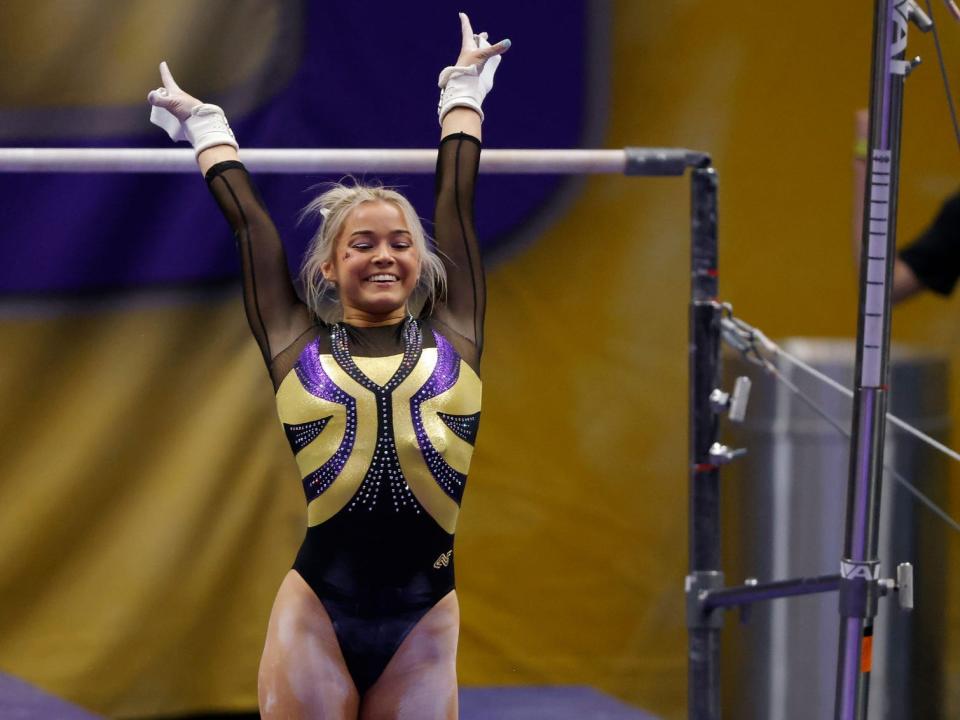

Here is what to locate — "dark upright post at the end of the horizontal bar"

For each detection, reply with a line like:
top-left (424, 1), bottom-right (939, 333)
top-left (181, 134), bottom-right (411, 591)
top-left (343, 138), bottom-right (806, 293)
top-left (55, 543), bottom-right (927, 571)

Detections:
top-left (686, 167), bottom-right (723, 720)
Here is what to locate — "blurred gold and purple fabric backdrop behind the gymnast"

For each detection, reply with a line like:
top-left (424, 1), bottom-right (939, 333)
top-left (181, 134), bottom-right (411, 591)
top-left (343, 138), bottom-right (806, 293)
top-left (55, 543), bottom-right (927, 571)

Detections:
top-left (0, 0), bottom-right (960, 718)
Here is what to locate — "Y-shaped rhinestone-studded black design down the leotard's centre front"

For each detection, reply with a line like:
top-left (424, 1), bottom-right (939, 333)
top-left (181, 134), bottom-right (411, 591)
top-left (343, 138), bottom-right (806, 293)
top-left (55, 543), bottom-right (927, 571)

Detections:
top-left (330, 317), bottom-right (423, 514)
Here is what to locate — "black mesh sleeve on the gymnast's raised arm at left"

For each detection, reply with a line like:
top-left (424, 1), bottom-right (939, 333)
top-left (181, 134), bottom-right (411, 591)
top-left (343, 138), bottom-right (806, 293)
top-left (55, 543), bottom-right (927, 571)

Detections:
top-left (206, 160), bottom-right (313, 362)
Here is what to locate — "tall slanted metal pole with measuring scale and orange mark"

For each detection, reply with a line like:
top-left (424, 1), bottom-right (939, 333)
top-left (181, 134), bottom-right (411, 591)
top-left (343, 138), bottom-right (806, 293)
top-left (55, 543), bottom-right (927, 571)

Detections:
top-left (834, 0), bottom-right (912, 720)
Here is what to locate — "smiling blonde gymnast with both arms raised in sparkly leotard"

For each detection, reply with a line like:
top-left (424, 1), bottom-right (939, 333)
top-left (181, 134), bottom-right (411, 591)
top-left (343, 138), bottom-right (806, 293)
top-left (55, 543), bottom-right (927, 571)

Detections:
top-left (148, 14), bottom-right (510, 720)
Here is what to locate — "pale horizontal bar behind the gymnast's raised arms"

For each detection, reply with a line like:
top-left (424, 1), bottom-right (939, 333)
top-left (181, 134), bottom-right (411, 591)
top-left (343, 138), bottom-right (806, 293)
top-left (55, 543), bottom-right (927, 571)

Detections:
top-left (0, 148), bottom-right (706, 176)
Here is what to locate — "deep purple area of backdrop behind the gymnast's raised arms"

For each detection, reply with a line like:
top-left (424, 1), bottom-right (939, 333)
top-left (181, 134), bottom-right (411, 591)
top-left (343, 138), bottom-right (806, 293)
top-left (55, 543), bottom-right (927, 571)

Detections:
top-left (0, 0), bottom-right (596, 294)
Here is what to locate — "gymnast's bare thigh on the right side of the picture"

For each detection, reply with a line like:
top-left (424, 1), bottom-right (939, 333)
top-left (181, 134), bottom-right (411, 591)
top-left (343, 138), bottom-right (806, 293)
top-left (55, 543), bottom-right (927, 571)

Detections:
top-left (360, 590), bottom-right (460, 720)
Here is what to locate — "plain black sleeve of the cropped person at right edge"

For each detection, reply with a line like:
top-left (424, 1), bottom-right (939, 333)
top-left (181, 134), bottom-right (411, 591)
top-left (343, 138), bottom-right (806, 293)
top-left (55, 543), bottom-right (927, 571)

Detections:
top-left (900, 193), bottom-right (960, 295)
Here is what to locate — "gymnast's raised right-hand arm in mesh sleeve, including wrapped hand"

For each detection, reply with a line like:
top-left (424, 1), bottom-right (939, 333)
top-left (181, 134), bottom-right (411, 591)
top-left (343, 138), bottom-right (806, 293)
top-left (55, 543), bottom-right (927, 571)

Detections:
top-left (434, 13), bottom-right (510, 355)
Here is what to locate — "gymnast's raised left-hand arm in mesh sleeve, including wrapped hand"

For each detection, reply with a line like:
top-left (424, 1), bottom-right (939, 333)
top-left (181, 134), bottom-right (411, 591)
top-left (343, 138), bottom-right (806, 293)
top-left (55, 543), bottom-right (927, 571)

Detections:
top-left (147, 63), bottom-right (313, 367)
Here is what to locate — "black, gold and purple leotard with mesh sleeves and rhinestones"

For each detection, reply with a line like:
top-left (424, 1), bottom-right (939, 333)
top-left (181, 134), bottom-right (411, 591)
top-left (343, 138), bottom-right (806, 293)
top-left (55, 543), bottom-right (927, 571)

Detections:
top-left (206, 133), bottom-right (485, 694)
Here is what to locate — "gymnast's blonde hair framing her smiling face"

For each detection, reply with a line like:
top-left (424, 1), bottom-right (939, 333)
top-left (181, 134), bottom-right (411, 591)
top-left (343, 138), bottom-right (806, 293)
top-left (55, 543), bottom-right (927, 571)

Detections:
top-left (300, 178), bottom-right (447, 320)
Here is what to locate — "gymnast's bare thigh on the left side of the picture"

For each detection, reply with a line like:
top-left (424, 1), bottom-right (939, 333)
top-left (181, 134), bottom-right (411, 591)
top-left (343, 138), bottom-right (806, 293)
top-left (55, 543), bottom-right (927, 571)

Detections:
top-left (257, 570), bottom-right (359, 720)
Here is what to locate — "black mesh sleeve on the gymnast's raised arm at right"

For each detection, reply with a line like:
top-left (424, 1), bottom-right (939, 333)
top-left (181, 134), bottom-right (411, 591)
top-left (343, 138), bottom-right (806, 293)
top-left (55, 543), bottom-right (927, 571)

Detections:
top-left (433, 133), bottom-right (486, 358)
